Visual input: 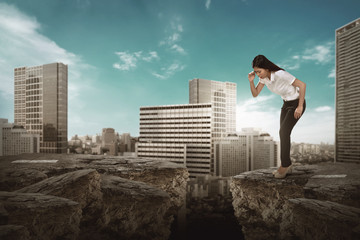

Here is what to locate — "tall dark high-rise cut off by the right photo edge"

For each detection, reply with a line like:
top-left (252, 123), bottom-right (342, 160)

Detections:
top-left (335, 18), bottom-right (360, 162)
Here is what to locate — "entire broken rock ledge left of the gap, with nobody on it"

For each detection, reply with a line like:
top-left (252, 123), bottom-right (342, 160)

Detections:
top-left (0, 154), bottom-right (189, 240)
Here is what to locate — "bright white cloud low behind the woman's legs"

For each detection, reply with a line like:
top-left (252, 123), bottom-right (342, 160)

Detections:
top-left (236, 95), bottom-right (335, 143)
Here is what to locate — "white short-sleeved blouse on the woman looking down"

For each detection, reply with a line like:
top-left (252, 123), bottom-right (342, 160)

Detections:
top-left (260, 70), bottom-right (299, 101)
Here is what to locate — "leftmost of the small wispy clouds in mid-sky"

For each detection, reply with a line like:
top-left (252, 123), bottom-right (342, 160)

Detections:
top-left (113, 51), bottom-right (159, 71)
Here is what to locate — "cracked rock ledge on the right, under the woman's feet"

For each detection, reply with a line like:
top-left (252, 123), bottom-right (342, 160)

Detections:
top-left (230, 163), bottom-right (360, 240)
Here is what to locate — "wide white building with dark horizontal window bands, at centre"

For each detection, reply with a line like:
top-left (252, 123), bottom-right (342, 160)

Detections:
top-left (136, 103), bottom-right (213, 177)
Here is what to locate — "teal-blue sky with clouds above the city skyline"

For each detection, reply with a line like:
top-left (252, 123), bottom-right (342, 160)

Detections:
top-left (0, 0), bottom-right (360, 143)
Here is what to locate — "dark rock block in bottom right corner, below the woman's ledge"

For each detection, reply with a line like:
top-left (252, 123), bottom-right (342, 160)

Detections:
top-left (280, 198), bottom-right (360, 240)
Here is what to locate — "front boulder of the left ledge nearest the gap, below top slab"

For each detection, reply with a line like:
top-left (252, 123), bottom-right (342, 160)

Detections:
top-left (97, 175), bottom-right (173, 240)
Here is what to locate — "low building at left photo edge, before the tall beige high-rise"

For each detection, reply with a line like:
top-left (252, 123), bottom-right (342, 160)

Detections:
top-left (0, 118), bottom-right (40, 156)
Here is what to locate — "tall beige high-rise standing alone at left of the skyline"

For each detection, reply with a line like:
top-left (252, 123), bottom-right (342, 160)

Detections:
top-left (14, 63), bottom-right (68, 153)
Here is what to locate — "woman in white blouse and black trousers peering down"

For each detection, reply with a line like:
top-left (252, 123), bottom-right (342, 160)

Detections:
top-left (248, 55), bottom-right (306, 178)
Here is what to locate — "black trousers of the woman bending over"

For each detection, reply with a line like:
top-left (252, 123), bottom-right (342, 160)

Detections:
top-left (279, 101), bottom-right (306, 167)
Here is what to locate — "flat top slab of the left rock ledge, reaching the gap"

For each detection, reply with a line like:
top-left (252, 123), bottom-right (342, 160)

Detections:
top-left (0, 154), bottom-right (189, 209)
